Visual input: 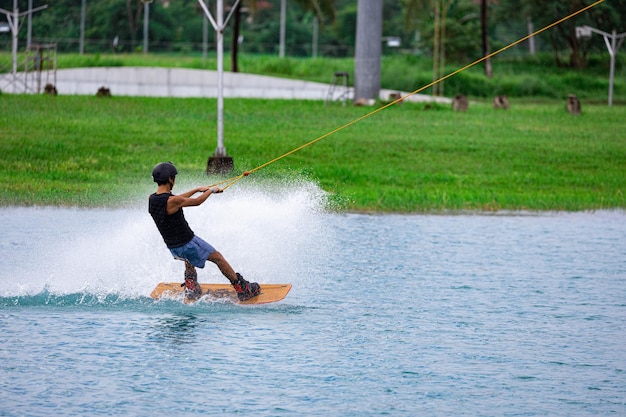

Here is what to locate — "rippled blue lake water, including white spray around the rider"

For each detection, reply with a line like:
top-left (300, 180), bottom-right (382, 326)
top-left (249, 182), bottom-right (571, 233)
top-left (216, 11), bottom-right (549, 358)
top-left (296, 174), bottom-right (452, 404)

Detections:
top-left (0, 184), bottom-right (626, 416)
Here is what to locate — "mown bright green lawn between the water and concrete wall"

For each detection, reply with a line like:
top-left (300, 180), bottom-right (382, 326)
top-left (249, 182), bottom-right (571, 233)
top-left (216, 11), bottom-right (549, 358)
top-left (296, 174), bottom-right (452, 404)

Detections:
top-left (0, 94), bottom-right (626, 212)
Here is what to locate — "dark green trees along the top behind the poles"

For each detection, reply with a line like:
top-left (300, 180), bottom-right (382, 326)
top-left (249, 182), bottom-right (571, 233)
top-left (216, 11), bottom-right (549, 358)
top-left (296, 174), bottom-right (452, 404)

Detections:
top-left (0, 0), bottom-right (626, 68)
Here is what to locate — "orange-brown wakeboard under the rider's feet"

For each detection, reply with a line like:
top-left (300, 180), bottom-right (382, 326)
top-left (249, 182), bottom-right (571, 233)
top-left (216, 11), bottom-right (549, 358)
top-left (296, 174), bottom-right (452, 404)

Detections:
top-left (150, 282), bottom-right (291, 304)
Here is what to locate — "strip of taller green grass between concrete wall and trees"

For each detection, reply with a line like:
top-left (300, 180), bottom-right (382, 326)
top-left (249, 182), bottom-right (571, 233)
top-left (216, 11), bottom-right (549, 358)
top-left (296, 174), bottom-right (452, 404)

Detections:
top-left (0, 53), bottom-right (626, 103)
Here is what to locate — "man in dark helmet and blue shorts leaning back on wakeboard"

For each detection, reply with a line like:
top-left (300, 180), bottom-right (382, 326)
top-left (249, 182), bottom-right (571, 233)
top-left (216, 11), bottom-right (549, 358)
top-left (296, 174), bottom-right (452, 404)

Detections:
top-left (148, 162), bottom-right (261, 301)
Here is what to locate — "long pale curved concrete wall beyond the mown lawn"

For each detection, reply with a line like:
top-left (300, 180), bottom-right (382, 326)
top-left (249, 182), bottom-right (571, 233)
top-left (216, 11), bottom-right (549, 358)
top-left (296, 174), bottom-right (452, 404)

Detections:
top-left (0, 67), bottom-right (449, 103)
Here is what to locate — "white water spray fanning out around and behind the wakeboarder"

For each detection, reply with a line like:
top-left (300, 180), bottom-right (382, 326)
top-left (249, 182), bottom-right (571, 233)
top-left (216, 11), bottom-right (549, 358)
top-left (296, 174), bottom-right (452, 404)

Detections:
top-left (0, 182), bottom-right (331, 298)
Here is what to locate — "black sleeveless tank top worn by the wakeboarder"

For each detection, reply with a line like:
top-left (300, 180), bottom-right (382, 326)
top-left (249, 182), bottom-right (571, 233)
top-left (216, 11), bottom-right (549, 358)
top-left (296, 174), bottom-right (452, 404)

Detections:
top-left (148, 193), bottom-right (194, 248)
